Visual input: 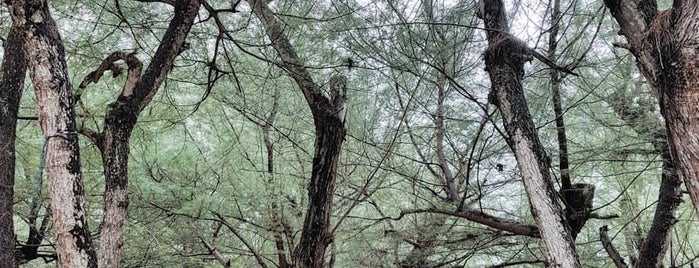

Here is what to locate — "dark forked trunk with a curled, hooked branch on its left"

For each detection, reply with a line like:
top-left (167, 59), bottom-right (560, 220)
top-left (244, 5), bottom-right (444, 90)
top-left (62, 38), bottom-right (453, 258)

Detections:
top-left (81, 0), bottom-right (200, 268)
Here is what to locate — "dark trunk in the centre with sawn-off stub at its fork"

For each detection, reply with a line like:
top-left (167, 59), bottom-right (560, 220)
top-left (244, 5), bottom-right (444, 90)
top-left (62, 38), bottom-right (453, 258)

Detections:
top-left (248, 0), bottom-right (347, 268)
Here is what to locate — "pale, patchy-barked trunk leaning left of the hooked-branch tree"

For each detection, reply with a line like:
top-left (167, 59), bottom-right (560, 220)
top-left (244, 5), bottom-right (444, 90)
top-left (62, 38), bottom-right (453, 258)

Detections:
top-left (8, 0), bottom-right (97, 267)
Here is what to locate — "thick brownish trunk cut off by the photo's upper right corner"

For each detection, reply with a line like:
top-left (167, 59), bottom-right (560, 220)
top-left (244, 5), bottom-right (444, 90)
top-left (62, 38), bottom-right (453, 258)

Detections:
top-left (604, 0), bottom-right (699, 222)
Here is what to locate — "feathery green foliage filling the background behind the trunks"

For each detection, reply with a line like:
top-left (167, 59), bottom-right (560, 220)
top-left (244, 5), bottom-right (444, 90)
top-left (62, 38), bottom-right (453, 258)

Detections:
top-left (0, 1), bottom-right (697, 267)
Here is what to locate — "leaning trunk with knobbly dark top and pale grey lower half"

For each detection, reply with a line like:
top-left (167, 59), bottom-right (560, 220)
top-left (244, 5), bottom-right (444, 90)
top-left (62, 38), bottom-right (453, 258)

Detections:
top-left (479, 0), bottom-right (580, 267)
